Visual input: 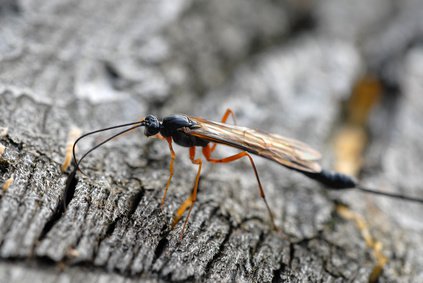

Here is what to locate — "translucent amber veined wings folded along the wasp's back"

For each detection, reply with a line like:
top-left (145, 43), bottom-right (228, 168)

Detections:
top-left (186, 117), bottom-right (322, 173)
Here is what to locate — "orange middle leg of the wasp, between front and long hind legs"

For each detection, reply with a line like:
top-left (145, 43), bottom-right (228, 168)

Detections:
top-left (172, 146), bottom-right (203, 239)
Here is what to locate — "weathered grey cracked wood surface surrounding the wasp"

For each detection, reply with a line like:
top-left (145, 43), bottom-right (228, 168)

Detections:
top-left (0, 0), bottom-right (423, 282)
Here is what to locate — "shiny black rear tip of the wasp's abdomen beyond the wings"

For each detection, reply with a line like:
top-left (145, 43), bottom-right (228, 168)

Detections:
top-left (300, 170), bottom-right (357, 190)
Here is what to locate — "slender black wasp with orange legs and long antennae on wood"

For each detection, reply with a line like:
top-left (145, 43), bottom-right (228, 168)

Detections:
top-left (65, 109), bottom-right (423, 237)
